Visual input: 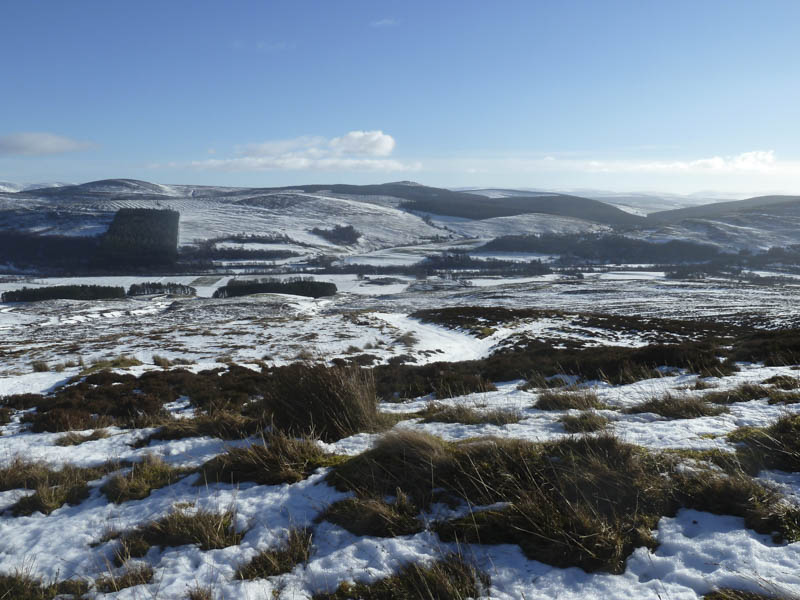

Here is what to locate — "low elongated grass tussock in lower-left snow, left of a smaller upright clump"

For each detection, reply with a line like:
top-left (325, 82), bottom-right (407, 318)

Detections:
top-left (115, 510), bottom-right (244, 565)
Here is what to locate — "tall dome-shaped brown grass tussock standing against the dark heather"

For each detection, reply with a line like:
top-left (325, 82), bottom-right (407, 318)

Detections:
top-left (246, 363), bottom-right (394, 442)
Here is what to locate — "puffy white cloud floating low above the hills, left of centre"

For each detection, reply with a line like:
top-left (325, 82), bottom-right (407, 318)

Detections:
top-left (184, 130), bottom-right (421, 171)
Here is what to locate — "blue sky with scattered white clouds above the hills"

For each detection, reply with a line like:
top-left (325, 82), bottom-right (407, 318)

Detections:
top-left (0, 0), bottom-right (800, 193)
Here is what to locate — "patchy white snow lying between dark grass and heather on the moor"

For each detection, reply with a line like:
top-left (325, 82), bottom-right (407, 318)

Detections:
top-left (0, 274), bottom-right (800, 600)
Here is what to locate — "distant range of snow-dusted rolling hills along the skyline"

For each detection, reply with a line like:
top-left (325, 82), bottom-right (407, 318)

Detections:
top-left (0, 179), bottom-right (800, 251)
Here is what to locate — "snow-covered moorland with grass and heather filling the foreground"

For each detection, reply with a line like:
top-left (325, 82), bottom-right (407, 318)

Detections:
top-left (0, 272), bottom-right (800, 599)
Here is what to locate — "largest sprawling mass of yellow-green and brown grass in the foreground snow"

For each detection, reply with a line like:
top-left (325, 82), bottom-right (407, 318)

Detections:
top-left (328, 432), bottom-right (800, 573)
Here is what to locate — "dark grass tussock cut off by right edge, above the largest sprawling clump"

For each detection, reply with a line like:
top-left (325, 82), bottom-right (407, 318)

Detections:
top-left (728, 415), bottom-right (800, 473)
